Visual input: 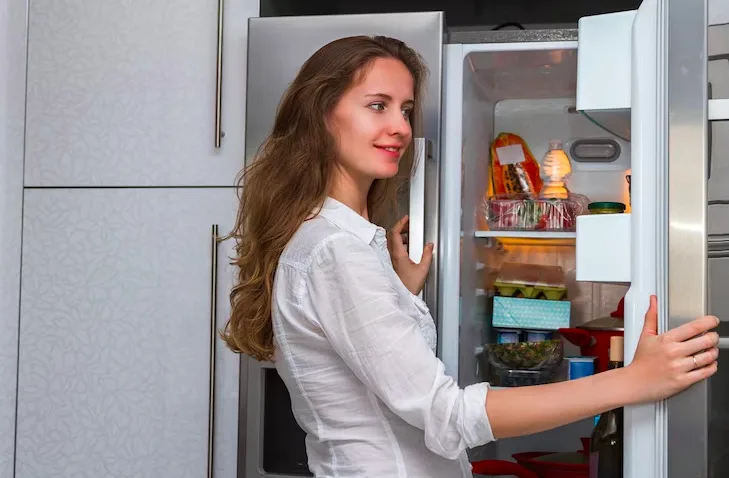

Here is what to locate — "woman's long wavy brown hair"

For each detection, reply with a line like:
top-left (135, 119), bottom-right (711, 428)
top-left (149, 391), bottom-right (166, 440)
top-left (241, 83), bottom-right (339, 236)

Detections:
top-left (222, 36), bottom-right (426, 360)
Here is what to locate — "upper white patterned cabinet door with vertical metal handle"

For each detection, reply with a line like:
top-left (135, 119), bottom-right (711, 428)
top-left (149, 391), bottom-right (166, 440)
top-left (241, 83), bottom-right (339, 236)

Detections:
top-left (25, 0), bottom-right (259, 186)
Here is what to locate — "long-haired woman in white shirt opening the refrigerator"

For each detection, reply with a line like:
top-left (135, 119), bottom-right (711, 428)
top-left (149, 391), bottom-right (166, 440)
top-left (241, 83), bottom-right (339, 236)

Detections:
top-left (224, 37), bottom-right (718, 478)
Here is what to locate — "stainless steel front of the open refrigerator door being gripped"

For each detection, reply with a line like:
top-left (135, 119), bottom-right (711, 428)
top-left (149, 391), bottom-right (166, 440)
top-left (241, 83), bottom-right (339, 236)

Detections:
top-left (657, 0), bottom-right (712, 478)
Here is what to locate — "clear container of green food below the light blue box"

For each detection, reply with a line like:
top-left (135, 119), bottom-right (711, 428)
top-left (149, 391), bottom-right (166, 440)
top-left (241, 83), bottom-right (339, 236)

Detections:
top-left (484, 340), bottom-right (564, 370)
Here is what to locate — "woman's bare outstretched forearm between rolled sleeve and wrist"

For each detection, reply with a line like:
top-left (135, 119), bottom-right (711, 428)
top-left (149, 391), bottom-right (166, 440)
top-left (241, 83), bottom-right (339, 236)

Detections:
top-left (486, 368), bottom-right (638, 439)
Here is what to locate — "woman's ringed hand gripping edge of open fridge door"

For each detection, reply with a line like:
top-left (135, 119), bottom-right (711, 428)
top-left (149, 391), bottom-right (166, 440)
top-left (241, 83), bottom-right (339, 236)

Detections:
top-left (626, 296), bottom-right (719, 402)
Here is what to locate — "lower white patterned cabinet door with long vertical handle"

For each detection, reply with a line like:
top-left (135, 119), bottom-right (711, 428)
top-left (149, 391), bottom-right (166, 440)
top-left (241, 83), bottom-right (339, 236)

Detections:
top-left (17, 188), bottom-right (239, 478)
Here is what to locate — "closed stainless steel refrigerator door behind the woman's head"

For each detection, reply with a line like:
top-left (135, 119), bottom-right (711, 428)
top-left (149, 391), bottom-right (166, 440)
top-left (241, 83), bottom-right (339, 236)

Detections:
top-left (239, 12), bottom-right (443, 478)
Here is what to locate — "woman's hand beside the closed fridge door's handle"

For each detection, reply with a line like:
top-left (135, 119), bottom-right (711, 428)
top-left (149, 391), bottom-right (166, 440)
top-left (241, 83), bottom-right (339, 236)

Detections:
top-left (387, 216), bottom-right (433, 295)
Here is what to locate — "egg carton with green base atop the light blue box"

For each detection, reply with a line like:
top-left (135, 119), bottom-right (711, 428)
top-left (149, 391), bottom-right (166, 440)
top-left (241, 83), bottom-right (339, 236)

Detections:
top-left (494, 262), bottom-right (567, 300)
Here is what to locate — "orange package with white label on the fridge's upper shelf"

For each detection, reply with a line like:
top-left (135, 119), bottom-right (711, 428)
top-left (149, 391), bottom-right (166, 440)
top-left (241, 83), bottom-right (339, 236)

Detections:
top-left (489, 133), bottom-right (543, 197)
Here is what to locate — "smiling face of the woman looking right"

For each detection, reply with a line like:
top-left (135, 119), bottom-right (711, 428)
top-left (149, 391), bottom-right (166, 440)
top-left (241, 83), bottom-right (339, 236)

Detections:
top-left (330, 58), bottom-right (413, 185)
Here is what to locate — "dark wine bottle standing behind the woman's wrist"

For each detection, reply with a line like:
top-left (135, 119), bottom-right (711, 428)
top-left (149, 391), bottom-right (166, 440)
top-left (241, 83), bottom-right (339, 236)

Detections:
top-left (589, 337), bottom-right (624, 478)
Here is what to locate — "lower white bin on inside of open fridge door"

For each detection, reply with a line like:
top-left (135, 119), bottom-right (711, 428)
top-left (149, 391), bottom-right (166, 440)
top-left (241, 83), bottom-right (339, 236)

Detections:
top-left (575, 214), bottom-right (631, 283)
